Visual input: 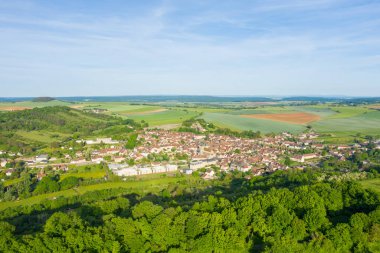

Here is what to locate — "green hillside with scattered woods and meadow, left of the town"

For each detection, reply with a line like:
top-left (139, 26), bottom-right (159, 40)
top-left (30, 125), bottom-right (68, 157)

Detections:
top-left (0, 106), bottom-right (139, 152)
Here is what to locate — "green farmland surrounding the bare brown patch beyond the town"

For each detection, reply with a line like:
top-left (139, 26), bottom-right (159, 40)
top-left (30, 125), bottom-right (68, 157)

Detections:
top-left (202, 104), bottom-right (380, 143)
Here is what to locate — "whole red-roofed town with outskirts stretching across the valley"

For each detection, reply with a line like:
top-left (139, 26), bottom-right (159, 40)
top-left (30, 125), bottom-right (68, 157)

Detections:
top-left (0, 129), bottom-right (380, 180)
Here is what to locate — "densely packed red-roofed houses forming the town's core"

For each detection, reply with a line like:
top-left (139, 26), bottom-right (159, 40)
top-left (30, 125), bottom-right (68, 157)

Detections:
top-left (133, 130), bottom-right (319, 175)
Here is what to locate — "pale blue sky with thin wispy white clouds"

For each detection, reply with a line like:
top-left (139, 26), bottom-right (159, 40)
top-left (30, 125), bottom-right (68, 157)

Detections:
top-left (0, 0), bottom-right (380, 97)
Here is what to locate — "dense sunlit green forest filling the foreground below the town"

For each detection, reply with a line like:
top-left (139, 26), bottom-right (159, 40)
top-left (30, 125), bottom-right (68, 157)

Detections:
top-left (0, 172), bottom-right (380, 252)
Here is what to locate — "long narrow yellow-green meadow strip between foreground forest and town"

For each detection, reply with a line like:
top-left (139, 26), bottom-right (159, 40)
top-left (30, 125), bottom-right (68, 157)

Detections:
top-left (0, 177), bottom-right (190, 211)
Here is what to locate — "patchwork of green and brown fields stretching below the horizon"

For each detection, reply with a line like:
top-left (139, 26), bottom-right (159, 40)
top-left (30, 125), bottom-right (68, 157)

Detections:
top-left (0, 100), bottom-right (380, 142)
